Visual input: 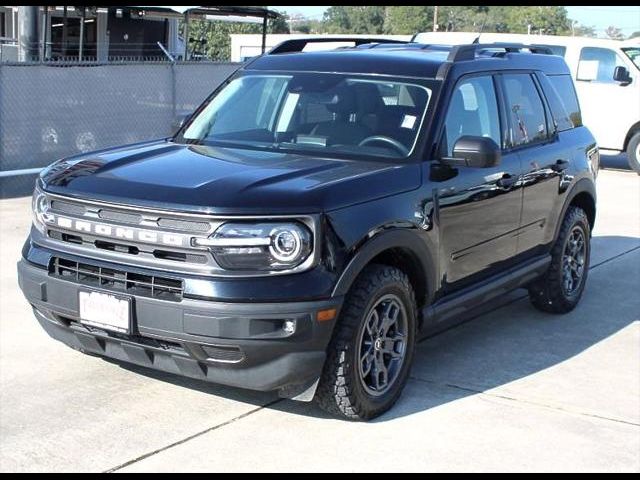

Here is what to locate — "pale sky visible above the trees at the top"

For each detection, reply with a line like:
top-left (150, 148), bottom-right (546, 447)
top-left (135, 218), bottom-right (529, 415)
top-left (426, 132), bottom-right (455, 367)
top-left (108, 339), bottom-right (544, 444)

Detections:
top-left (271, 5), bottom-right (640, 36)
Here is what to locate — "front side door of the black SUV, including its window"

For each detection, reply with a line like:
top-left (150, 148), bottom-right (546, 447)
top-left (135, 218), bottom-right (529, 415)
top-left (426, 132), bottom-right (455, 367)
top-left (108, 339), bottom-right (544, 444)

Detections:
top-left (432, 75), bottom-right (522, 291)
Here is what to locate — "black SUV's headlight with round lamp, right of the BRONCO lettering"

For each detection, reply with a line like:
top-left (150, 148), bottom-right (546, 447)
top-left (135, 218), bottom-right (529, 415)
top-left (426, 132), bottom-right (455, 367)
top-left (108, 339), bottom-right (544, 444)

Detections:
top-left (195, 222), bottom-right (312, 271)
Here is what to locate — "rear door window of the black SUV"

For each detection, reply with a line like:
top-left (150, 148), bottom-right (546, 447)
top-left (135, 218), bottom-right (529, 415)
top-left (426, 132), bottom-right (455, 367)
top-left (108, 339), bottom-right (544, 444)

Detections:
top-left (504, 74), bottom-right (547, 147)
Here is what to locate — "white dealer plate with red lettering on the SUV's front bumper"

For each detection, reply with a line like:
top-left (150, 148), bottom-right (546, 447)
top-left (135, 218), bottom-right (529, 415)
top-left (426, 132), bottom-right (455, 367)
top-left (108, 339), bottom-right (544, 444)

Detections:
top-left (79, 291), bottom-right (131, 333)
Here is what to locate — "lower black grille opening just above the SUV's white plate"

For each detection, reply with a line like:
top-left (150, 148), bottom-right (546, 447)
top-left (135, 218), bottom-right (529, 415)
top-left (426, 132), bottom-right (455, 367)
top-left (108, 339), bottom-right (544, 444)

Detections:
top-left (50, 257), bottom-right (184, 302)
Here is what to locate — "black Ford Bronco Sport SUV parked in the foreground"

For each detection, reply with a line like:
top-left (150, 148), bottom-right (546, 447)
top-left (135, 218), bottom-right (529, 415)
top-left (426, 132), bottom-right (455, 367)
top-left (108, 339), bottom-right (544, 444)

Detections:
top-left (18, 39), bottom-right (599, 419)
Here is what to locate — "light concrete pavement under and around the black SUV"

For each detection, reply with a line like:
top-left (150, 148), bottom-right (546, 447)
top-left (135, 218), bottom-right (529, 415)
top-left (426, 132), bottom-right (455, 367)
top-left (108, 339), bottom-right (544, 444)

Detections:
top-left (0, 166), bottom-right (640, 472)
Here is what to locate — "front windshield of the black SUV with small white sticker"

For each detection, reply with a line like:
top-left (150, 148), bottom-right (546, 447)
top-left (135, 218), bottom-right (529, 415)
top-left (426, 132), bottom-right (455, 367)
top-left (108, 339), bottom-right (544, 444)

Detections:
top-left (176, 72), bottom-right (431, 158)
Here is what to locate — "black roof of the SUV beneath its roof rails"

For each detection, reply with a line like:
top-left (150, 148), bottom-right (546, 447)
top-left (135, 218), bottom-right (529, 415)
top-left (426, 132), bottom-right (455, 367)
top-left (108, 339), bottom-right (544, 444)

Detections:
top-left (245, 42), bottom-right (569, 78)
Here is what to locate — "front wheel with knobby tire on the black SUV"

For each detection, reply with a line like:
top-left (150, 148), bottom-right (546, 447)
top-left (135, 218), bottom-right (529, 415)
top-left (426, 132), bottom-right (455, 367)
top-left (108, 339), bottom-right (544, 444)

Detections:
top-left (315, 264), bottom-right (417, 420)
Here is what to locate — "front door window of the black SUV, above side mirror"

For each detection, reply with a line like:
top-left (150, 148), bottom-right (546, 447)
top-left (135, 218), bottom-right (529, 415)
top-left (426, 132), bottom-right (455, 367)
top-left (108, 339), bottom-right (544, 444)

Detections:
top-left (440, 77), bottom-right (501, 156)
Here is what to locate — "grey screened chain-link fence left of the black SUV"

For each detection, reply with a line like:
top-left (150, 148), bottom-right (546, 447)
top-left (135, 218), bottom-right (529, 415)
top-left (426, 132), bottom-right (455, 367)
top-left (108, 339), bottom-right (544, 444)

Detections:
top-left (0, 62), bottom-right (240, 198)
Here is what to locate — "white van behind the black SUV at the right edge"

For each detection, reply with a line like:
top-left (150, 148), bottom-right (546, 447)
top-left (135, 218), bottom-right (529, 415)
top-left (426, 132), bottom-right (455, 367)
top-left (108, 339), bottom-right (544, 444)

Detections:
top-left (414, 32), bottom-right (640, 174)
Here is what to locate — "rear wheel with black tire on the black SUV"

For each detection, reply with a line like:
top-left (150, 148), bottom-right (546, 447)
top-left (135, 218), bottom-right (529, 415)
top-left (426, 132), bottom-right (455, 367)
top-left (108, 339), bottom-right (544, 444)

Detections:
top-left (529, 206), bottom-right (591, 313)
